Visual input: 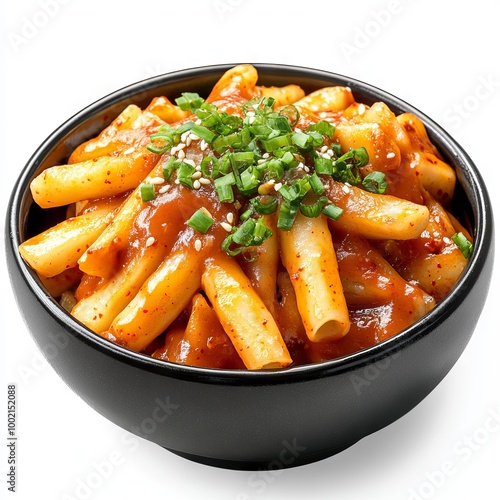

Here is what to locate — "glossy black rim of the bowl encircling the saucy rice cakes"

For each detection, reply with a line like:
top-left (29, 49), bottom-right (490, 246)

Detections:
top-left (6, 63), bottom-right (493, 385)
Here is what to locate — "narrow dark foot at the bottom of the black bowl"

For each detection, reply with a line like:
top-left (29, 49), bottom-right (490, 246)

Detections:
top-left (165, 441), bottom-right (357, 471)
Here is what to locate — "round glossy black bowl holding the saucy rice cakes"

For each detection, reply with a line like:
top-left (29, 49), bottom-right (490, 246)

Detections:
top-left (6, 64), bottom-right (493, 469)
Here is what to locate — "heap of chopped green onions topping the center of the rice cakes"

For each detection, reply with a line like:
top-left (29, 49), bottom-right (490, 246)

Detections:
top-left (145, 92), bottom-right (376, 255)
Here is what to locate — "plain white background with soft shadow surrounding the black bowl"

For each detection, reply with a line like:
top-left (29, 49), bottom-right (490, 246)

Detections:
top-left (0, 0), bottom-right (500, 500)
